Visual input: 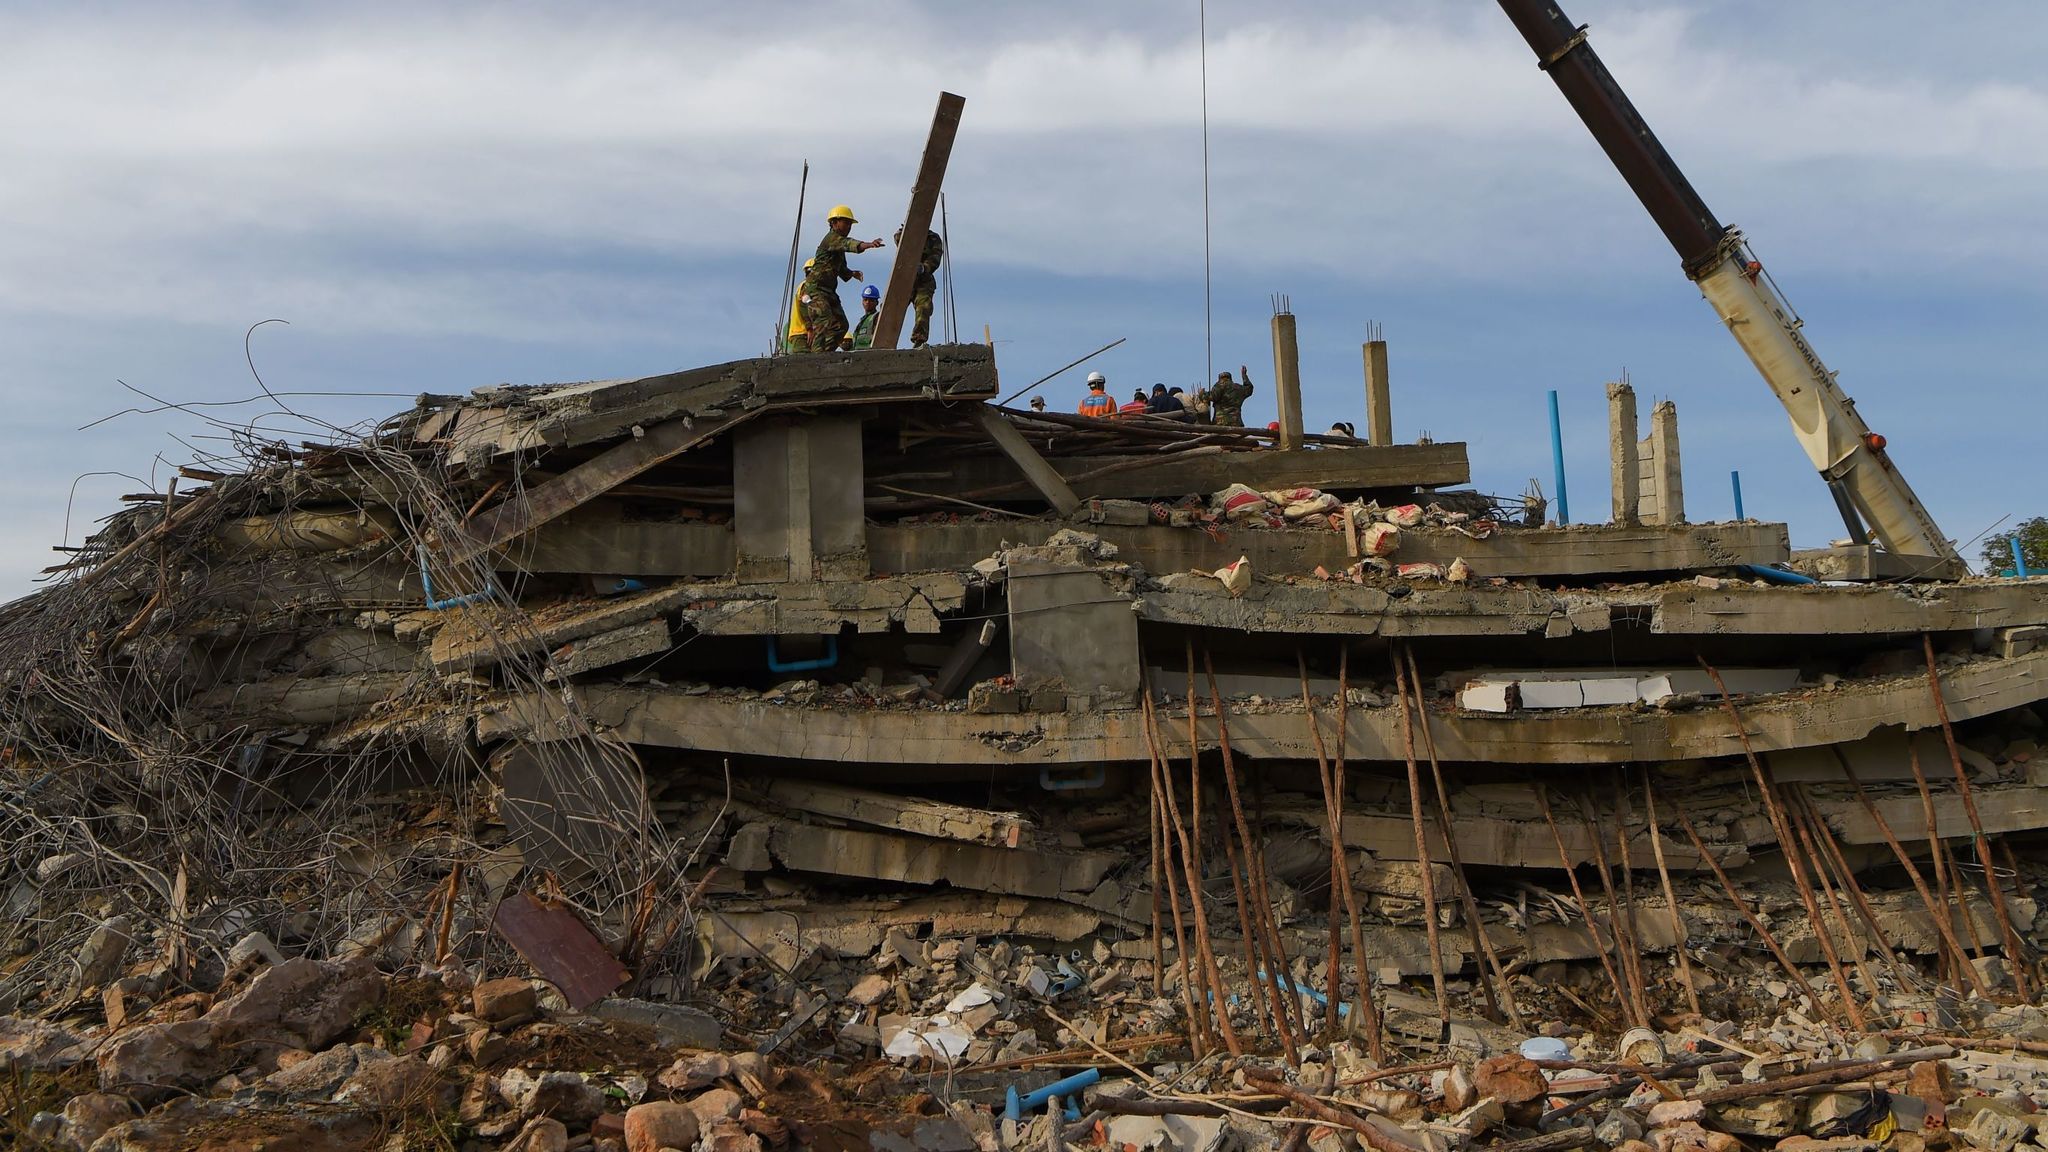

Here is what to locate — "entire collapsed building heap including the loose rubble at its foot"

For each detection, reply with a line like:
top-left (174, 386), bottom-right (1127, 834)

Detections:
top-left (0, 346), bottom-right (2048, 1152)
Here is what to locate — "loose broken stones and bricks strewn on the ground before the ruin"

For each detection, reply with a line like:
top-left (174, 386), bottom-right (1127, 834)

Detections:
top-left (12, 933), bottom-right (2048, 1152)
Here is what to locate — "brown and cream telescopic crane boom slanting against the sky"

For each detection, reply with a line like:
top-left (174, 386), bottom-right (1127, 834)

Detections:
top-left (1499, 0), bottom-right (1958, 562)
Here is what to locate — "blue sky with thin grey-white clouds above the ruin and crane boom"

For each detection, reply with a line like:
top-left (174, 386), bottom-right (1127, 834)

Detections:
top-left (0, 0), bottom-right (2048, 599)
